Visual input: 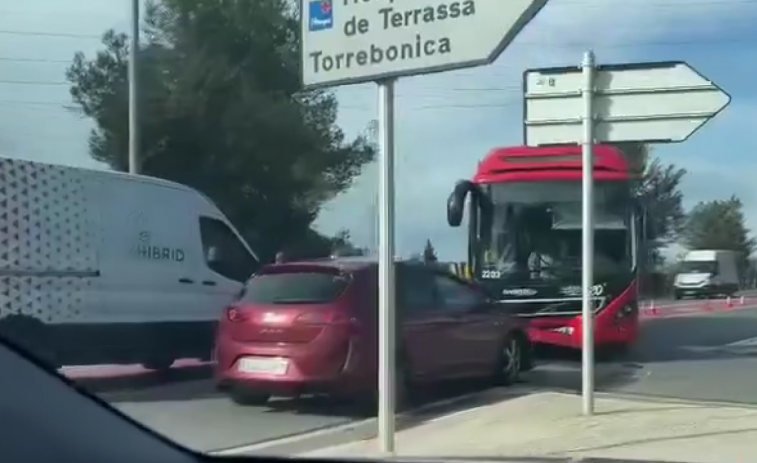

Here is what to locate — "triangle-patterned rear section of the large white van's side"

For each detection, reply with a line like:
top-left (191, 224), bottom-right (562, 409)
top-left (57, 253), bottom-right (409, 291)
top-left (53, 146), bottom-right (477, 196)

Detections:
top-left (0, 158), bottom-right (99, 322)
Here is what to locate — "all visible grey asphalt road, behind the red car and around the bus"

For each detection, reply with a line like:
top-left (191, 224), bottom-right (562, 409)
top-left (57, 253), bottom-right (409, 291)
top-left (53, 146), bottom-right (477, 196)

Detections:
top-left (79, 301), bottom-right (757, 451)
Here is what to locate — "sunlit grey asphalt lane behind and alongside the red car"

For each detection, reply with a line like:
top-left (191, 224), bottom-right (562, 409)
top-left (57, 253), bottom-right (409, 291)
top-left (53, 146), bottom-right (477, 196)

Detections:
top-left (98, 374), bottom-right (502, 451)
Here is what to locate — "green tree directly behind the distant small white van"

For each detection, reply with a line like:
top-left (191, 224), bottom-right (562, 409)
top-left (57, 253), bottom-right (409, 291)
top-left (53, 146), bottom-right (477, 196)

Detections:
top-left (683, 195), bottom-right (757, 271)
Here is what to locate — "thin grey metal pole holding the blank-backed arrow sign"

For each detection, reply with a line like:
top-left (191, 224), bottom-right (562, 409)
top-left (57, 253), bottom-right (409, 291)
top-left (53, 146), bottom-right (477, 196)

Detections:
top-left (581, 51), bottom-right (594, 415)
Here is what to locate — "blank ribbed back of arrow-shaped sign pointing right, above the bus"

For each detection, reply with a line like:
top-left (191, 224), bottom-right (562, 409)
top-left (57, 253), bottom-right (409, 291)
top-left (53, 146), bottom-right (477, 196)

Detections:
top-left (523, 61), bottom-right (731, 146)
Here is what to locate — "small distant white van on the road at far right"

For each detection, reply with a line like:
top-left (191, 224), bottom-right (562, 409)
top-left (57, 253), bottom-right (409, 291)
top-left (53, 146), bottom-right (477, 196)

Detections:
top-left (673, 249), bottom-right (739, 299)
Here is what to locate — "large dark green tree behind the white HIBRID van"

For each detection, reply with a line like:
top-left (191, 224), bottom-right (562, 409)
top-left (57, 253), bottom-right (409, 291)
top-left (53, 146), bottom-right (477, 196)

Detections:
top-left (67, 0), bottom-right (374, 258)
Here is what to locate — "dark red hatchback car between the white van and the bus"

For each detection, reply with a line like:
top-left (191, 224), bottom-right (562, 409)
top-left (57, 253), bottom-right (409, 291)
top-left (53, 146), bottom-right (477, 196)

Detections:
top-left (215, 258), bottom-right (532, 404)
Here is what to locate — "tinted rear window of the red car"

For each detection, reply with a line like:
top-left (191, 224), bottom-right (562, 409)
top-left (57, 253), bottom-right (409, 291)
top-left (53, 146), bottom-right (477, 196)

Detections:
top-left (240, 271), bottom-right (352, 304)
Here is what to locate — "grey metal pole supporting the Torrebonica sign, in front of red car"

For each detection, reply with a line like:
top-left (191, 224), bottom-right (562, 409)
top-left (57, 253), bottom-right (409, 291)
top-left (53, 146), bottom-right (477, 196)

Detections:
top-left (378, 80), bottom-right (396, 455)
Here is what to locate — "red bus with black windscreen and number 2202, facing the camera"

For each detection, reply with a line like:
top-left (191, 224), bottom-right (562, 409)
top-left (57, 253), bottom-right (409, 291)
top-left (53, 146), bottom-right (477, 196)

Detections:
top-left (447, 145), bottom-right (645, 355)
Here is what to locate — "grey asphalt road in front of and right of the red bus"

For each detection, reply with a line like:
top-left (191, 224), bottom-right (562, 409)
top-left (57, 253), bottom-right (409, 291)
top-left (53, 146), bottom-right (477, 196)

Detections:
top-left (528, 306), bottom-right (757, 405)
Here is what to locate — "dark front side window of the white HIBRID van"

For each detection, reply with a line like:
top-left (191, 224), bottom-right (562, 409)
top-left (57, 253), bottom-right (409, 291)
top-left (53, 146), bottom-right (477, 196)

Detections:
top-left (200, 217), bottom-right (258, 283)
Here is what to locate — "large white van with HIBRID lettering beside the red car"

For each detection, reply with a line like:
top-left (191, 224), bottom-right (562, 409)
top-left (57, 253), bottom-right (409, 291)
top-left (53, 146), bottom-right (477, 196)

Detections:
top-left (0, 158), bottom-right (258, 369)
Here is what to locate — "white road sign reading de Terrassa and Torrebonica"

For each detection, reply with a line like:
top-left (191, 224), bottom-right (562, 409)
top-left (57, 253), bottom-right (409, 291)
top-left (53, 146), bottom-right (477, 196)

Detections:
top-left (301, 0), bottom-right (548, 87)
